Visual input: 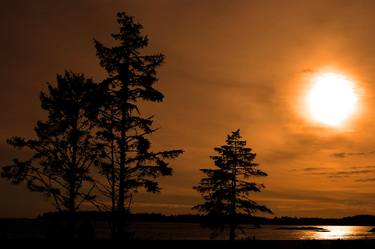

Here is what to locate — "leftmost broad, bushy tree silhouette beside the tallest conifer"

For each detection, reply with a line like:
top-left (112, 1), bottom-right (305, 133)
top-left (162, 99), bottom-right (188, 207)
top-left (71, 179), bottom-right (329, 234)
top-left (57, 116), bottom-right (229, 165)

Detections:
top-left (1, 72), bottom-right (101, 236)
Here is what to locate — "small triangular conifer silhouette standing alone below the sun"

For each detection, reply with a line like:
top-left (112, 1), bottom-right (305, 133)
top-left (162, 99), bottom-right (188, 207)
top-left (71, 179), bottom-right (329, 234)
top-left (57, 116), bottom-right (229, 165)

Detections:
top-left (193, 130), bottom-right (272, 240)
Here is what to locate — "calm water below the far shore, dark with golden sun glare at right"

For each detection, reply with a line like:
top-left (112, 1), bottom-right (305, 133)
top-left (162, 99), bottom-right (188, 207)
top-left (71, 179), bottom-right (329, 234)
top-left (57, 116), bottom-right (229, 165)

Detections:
top-left (0, 221), bottom-right (375, 240)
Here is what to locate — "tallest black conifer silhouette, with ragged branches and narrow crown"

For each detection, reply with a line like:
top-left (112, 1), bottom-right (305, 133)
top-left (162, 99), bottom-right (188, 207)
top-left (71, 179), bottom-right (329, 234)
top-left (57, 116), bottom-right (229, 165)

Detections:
top-left (94, 12), bottom-right (182, 238)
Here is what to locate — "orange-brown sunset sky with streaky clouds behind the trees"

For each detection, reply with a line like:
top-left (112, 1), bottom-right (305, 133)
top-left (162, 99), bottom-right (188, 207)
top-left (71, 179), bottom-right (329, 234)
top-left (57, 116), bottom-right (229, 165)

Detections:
top-left (0, 0), bottom-right (375, 217)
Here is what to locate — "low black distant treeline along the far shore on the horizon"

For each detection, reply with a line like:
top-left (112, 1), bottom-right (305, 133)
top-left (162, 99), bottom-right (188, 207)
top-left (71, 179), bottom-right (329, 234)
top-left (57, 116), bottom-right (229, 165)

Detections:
top-left (38, 211), bottom-right (375, 226)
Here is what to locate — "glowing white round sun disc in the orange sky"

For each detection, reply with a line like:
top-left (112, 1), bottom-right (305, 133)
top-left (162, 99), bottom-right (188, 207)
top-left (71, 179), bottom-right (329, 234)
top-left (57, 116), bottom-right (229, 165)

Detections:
top-left (306, 73), bottom-right (358, 127)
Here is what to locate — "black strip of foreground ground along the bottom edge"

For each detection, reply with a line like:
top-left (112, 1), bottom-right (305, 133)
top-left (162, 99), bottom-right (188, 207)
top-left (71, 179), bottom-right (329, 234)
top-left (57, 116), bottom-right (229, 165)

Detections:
top-left (0, 240), bottom-right (375, 249)
